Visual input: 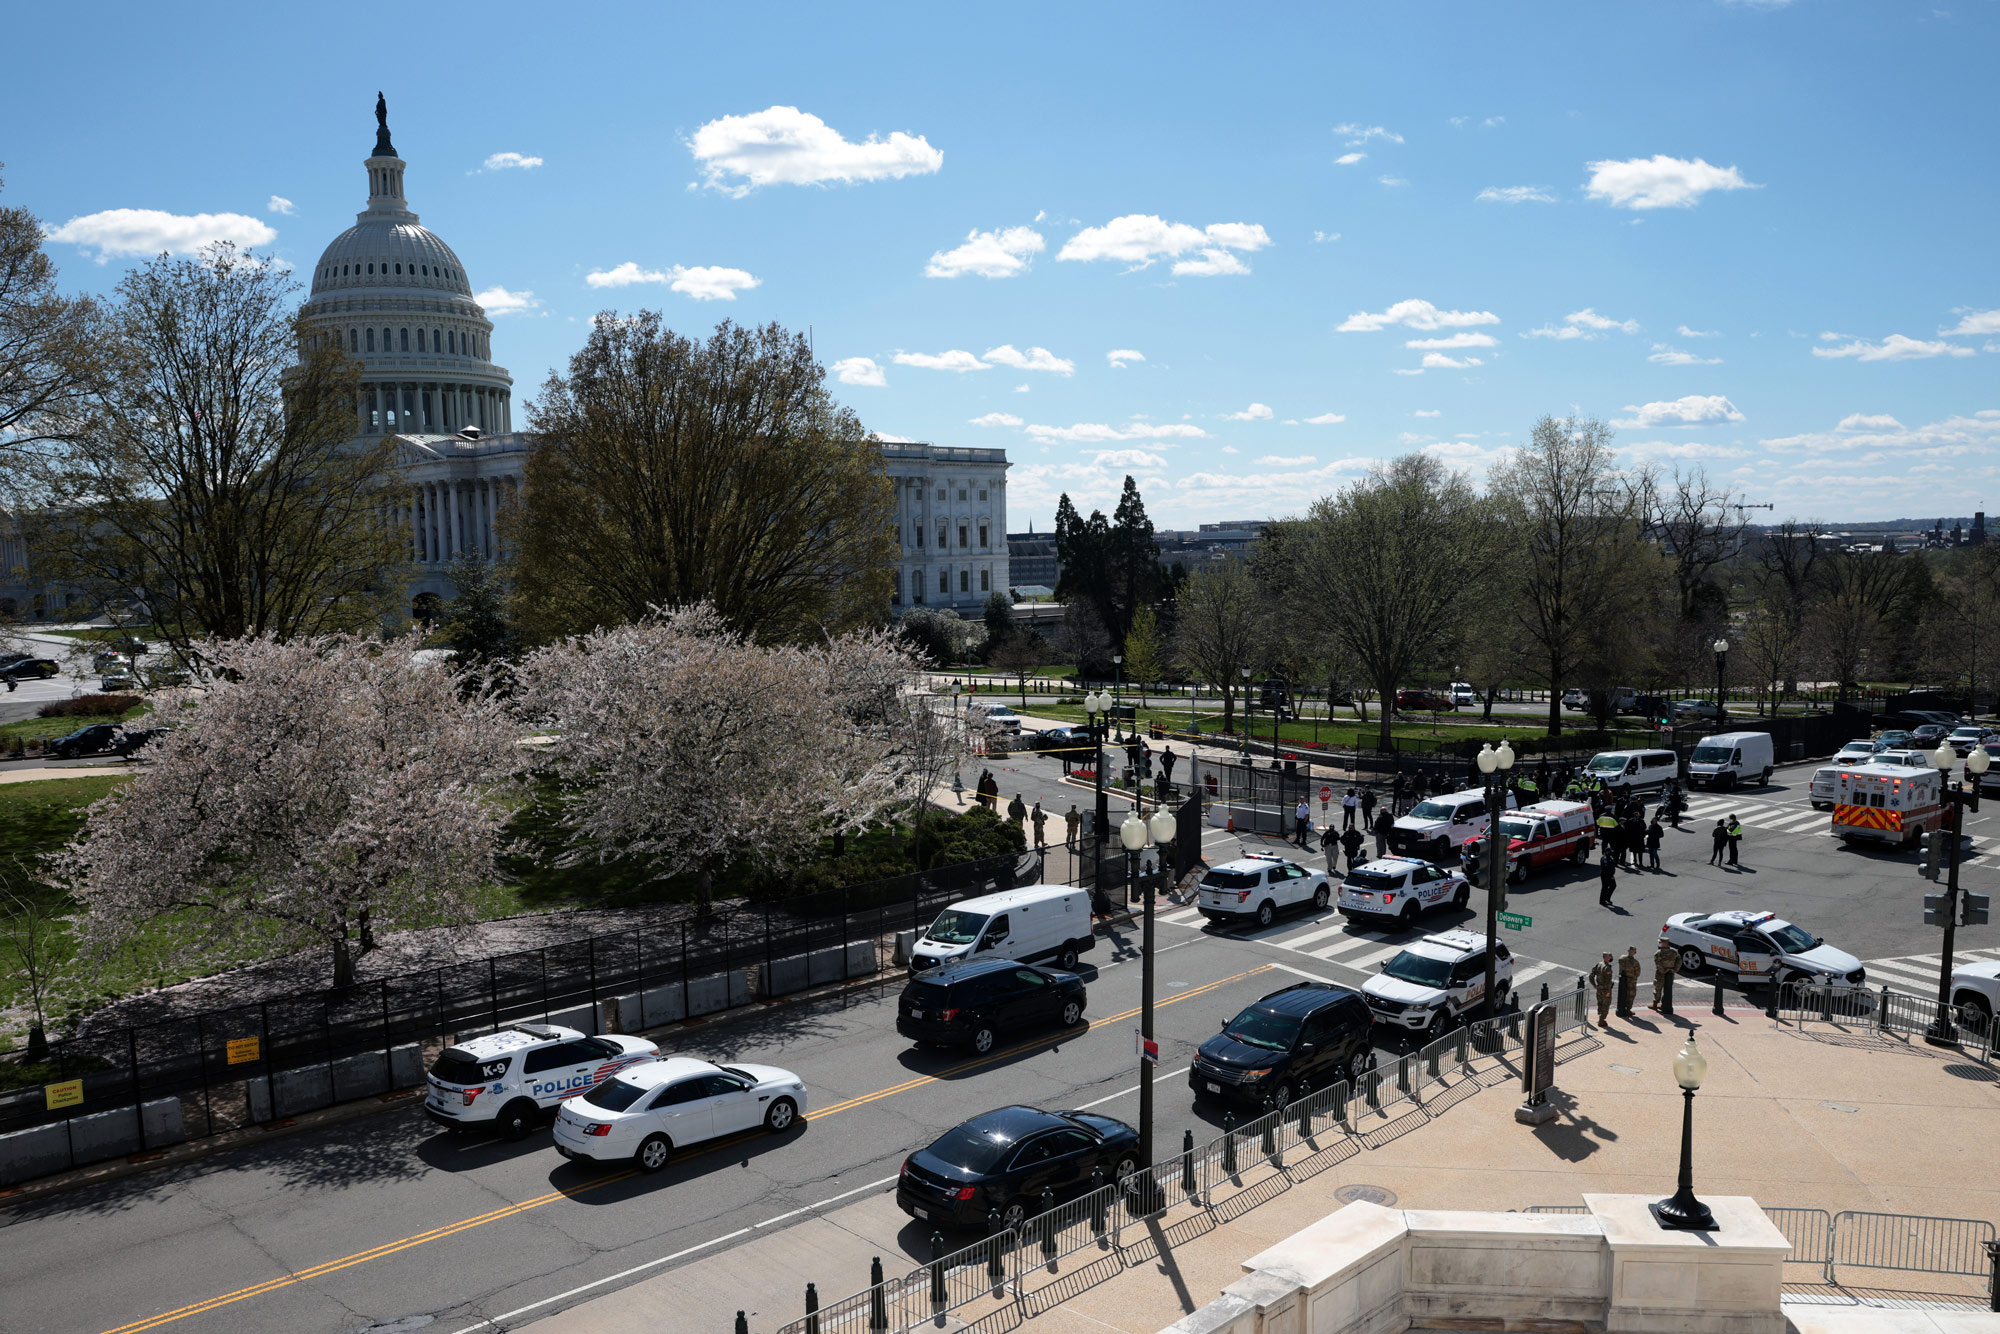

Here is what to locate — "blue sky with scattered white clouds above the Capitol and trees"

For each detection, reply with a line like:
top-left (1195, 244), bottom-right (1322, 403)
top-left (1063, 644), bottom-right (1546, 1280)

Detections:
top-left (0, 0), bottom-right (2000, 530)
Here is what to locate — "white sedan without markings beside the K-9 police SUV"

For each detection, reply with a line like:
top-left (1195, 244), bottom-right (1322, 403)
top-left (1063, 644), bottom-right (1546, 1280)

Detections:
top-left (556, 1056), bottom-right (806, 1172)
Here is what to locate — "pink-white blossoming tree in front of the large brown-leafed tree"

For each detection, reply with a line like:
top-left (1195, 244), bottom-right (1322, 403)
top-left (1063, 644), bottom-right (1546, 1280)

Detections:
top-left (520, 604), bottom-right (956, 910)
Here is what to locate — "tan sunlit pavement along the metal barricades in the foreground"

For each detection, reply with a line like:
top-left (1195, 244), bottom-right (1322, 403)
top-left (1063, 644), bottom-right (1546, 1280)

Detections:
top-left (516, 1010), bottom-right (2000, 1334)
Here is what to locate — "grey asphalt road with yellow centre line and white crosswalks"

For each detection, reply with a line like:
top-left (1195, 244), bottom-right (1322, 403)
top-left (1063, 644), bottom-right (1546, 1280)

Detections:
top-left (0, 756), bottom-right (2000, 1334)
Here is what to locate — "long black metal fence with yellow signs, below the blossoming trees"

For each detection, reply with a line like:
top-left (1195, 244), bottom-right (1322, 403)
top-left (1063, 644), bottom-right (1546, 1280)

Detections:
top-left (0, 854), bottom-right (1064, 1186)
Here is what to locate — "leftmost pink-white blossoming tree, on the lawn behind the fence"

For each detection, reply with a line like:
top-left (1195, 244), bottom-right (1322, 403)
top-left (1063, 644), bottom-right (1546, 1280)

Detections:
top-left (54, 636), bottom-right (522, 986)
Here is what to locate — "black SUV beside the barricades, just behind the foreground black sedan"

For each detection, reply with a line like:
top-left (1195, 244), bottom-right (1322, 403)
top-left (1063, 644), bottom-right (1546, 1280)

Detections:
top-left (1188, 982), bottom-right (1376, 1108)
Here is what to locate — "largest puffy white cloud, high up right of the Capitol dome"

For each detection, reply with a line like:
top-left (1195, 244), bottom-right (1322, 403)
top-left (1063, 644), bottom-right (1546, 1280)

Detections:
top-left (688, 106), bottom-right (944, 198)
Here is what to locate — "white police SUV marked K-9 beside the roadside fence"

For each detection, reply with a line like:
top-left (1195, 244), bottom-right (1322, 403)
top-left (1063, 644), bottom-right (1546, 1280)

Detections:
top-left (424, 1024), bottom-right (660, 1140)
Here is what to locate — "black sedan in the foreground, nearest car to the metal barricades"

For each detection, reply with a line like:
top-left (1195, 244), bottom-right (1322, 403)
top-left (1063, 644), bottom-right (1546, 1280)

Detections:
top-left (896, 1106), bottom-right (1140, 1232)
